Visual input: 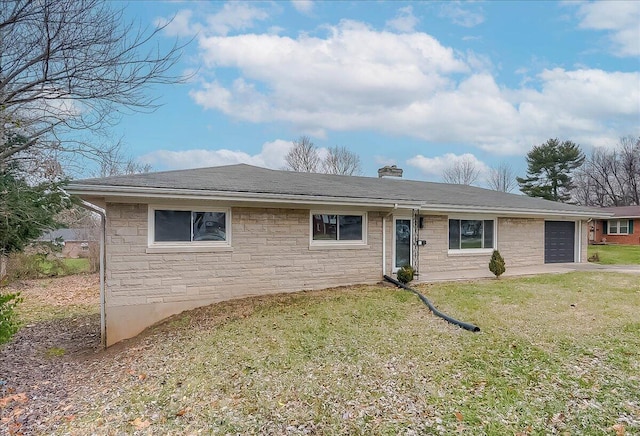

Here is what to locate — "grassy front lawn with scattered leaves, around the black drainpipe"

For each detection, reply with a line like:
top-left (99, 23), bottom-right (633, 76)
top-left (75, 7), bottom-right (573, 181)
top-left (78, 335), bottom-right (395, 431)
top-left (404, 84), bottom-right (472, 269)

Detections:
top-left (37, 272), bottom-right (640, 435)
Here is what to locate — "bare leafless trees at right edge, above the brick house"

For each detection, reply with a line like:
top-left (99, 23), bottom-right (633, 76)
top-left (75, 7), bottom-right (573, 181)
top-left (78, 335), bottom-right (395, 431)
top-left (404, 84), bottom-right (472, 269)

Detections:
top-left (573, 136), bottom-right (640, 207)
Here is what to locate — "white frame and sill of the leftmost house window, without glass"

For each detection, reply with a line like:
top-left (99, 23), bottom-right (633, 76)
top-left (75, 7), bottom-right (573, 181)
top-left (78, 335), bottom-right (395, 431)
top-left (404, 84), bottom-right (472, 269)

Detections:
top-left (147, 204), bottom-right (231, 249)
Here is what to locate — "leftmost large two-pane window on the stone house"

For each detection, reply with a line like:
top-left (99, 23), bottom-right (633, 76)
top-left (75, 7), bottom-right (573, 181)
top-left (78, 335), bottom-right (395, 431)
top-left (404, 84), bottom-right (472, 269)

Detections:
top-left (153, 209), bottom-right (228, 243)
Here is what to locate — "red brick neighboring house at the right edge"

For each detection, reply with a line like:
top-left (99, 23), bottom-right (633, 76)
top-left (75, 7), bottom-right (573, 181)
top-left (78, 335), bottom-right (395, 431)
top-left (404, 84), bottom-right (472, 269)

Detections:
top-left (589, 206), bottom-right (640, 245)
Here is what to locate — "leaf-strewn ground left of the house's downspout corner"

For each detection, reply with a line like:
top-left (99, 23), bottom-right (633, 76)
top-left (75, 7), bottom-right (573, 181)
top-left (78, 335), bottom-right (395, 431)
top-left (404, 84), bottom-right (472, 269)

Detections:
top-left (0, 275), bottom-right (100, 434)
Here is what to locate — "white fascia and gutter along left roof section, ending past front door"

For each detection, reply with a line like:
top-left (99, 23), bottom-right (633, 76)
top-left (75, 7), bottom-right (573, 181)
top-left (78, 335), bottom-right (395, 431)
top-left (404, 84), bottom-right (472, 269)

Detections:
top-left (66, 184), bottom-right (420, 209)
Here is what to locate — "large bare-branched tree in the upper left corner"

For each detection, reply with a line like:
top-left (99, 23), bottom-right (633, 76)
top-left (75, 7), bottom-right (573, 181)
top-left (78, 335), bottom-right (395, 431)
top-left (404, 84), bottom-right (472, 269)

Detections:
top-left (0, 0), bottom-right (185, 169)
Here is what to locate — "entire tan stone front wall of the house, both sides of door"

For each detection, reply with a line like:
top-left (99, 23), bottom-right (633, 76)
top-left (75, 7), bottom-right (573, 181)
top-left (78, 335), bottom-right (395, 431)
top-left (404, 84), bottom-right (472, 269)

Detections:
top-left (105, 203), bottom-right (592, 345)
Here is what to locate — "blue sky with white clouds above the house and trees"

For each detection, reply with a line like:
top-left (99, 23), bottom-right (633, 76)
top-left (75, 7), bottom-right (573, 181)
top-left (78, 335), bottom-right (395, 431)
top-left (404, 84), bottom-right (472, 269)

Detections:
top-left (114, 1), bottom-right (640, 186)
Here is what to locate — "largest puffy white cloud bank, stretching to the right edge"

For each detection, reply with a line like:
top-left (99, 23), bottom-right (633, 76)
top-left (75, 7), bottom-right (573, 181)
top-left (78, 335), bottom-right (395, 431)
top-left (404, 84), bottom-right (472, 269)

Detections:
top-left (182, 21), bottom-right (640, 158)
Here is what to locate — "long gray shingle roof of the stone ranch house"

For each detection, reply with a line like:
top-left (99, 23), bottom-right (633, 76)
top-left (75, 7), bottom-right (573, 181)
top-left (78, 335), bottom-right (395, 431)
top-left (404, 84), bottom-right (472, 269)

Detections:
top-left (70, 164), bottom-right (603, 216)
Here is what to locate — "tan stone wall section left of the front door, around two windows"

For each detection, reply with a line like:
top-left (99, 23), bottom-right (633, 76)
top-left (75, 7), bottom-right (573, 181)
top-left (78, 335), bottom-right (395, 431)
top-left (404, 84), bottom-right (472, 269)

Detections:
top-left (106, 203), bottom-right (382, 345)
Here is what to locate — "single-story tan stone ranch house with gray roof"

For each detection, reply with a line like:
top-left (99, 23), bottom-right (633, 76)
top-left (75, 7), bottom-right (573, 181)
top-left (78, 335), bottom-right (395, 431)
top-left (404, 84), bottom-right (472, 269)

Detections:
top-left (68, 164), bottom-right (608, 345)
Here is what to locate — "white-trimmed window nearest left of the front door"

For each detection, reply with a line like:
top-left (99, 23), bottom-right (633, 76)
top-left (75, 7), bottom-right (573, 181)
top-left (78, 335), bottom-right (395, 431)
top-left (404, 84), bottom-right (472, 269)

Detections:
top-left (311, 212), bottom-right (367, 244)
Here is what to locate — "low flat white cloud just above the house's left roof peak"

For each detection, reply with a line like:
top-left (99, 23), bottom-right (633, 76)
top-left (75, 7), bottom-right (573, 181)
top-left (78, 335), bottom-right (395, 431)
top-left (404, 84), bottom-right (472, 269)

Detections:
top-left (138, 139), bottom-right (293, 169)
